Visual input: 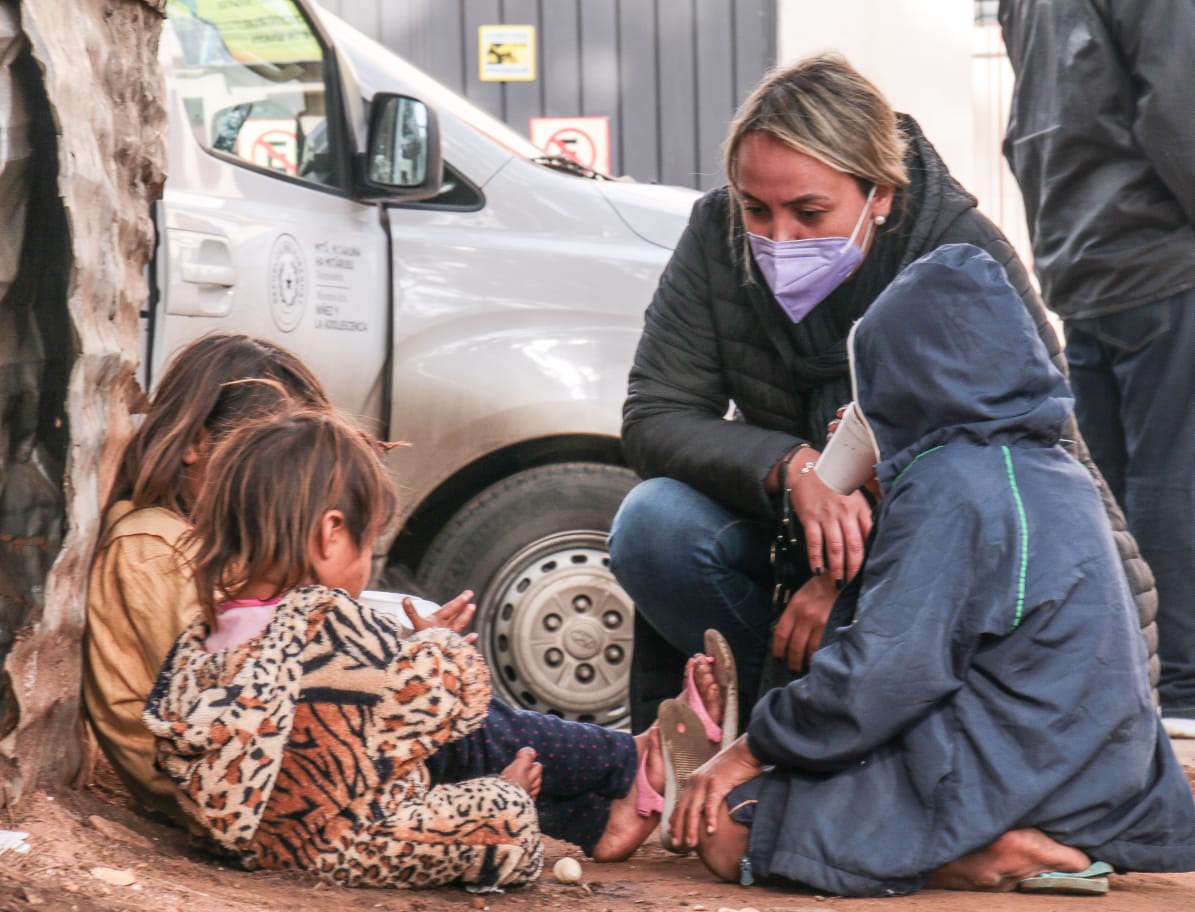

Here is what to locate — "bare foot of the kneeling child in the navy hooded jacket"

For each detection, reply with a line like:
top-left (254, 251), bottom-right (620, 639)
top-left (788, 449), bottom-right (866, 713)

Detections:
top-left (929, 830), bottom-right (1091, 893)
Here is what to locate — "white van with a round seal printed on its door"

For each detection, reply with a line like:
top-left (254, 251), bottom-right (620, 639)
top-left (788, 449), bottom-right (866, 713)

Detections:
top-left (145, 0), bottom-right (697, 724)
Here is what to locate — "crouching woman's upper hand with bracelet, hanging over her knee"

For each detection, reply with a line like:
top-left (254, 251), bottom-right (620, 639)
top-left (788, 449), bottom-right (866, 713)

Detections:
top-left (786, 447), bottom-right (871, 586)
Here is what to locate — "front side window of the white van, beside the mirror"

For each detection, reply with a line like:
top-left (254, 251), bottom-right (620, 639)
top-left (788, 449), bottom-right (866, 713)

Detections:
top-left (166, 0), bottom-right (343, 184)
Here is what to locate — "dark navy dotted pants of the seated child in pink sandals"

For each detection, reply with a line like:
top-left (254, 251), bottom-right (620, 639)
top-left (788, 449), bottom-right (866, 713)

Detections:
top-left (428, 700), bottom-right (638, 855)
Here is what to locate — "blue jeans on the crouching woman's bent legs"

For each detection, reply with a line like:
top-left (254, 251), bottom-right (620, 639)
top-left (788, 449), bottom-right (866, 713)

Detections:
top-left (609, 478), bottom-right (773, 728)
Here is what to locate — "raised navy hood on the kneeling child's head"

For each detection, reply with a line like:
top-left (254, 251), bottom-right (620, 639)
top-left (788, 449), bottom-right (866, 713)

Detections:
top-left (851, 244), bottom-right (1073, 484)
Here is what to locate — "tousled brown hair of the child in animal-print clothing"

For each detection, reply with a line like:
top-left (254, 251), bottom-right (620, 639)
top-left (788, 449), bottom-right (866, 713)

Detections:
top-left (184, 409), bottom-right (397, 628)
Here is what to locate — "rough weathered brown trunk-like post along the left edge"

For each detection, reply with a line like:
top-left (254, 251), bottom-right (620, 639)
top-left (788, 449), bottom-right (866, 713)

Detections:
top-left (0, 0), bottom-right (166, 807)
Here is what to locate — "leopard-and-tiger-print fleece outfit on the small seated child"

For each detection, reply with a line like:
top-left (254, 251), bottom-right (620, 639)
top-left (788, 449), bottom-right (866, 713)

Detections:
top-left (145, 586), bottom-right (543, 888)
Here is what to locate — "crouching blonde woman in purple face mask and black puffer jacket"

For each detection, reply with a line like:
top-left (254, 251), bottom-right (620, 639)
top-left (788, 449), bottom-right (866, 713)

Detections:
top-left (611, 54), bottom-right (1141, 726)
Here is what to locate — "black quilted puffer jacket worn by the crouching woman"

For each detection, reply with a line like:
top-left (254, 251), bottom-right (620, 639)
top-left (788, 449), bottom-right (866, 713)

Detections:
top-left (623, 116), bottom-right (1157, 681)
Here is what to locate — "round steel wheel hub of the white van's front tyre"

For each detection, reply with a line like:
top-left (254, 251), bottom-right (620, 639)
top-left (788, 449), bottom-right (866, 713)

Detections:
top-left (478, 531), bottom-right (635, 727)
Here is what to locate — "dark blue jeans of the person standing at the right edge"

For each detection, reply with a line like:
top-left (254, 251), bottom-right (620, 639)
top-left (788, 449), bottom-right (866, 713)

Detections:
top-left (1066, 289), bottom-right (1195, 718)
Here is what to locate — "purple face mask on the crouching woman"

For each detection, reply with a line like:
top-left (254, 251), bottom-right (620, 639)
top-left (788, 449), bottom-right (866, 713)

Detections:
top-left (747, 186), bottom-right (876, 323)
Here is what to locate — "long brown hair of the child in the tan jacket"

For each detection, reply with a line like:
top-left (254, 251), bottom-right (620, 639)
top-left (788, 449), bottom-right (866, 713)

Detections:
top-left (114, 332), bottom-right (331, 514)
